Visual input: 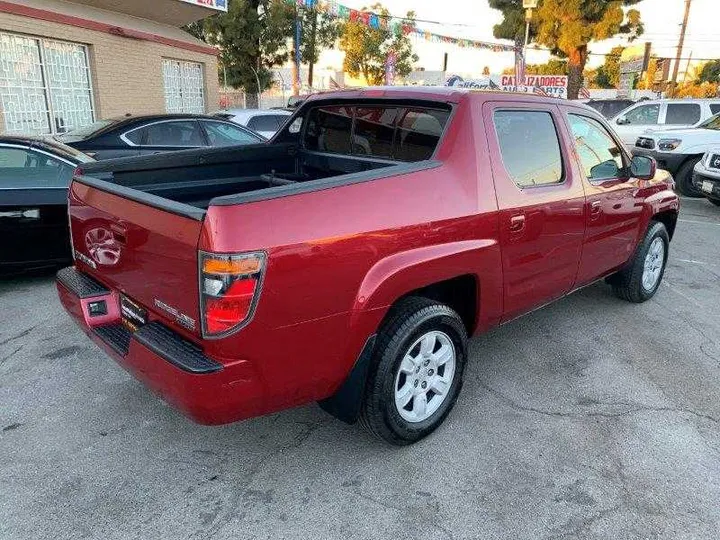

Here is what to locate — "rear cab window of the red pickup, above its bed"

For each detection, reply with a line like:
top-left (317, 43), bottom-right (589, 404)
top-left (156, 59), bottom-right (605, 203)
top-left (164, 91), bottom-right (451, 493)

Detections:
top-left (304, 106), bottom-right (450, 161)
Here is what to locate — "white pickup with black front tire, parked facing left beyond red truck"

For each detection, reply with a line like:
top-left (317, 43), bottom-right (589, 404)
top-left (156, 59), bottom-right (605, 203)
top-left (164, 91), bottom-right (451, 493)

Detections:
top-left (632, 114), bottom-right (720, 197)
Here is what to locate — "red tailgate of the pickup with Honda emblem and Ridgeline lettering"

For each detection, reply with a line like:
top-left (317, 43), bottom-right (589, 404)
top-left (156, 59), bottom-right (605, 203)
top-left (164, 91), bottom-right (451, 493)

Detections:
top-left (69, 177), bottom-right (203, 336)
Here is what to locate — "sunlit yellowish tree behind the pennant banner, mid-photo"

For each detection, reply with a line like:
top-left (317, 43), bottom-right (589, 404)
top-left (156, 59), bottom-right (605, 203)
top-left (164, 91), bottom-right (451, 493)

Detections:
top-left (340, 4), bottom-right (418, 85)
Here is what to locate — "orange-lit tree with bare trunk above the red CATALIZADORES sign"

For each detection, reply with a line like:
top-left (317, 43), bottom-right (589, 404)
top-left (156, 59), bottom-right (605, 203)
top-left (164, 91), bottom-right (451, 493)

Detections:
top-left (489, 0), bottom-right (643, 99)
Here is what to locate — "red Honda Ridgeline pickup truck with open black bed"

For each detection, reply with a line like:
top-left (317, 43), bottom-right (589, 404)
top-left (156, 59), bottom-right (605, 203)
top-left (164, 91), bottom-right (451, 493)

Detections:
top-left (57, 88), bottom-right (679, 444)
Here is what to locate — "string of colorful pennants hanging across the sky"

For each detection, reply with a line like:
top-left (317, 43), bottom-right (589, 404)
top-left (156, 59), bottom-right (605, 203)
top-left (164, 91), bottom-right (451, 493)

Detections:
top-left (285, 0), bottom-right (515, 52)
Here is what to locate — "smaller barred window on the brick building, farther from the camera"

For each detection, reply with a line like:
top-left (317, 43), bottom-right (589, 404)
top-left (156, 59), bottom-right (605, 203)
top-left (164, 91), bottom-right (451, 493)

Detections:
top-left (163, 59), bottom-right (205, 114)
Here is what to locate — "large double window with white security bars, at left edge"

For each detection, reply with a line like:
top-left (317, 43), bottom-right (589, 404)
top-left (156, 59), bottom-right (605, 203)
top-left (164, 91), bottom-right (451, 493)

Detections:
top-left (0, 32), bottom-right (95, 135)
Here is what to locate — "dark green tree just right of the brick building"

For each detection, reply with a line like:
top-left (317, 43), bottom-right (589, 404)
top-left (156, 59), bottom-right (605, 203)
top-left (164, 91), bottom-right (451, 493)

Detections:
top-left (186, 0), bottom-right (295, 107)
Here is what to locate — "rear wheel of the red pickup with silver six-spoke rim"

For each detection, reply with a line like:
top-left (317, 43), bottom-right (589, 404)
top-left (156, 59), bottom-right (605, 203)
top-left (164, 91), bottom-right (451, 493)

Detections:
top-left (360, 297), bottom-right (467, 446)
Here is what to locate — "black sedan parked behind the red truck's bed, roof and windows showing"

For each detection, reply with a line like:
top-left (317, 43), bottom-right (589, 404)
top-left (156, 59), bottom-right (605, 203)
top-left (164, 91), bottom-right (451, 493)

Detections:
top-left (56, 114), bottom-right (265, 159)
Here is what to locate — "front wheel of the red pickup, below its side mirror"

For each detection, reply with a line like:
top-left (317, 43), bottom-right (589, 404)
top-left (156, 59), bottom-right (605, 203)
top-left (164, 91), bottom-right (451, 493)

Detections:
top-left (611, 221), bottom-right (670, 304)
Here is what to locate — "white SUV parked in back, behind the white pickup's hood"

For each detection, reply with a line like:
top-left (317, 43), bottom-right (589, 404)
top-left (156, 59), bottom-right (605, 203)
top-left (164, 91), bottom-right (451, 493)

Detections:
top-left (610, 98), bottom-right (720, 147)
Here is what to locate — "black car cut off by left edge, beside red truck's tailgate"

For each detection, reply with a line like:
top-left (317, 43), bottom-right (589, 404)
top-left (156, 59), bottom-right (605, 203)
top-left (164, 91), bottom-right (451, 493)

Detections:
top-left (0, 135), bottom-right (92, 274)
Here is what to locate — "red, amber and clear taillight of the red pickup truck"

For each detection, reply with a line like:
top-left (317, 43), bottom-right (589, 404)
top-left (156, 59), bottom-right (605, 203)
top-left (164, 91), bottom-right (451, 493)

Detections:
top-left (200, 252), bottom-right (265, 337)
